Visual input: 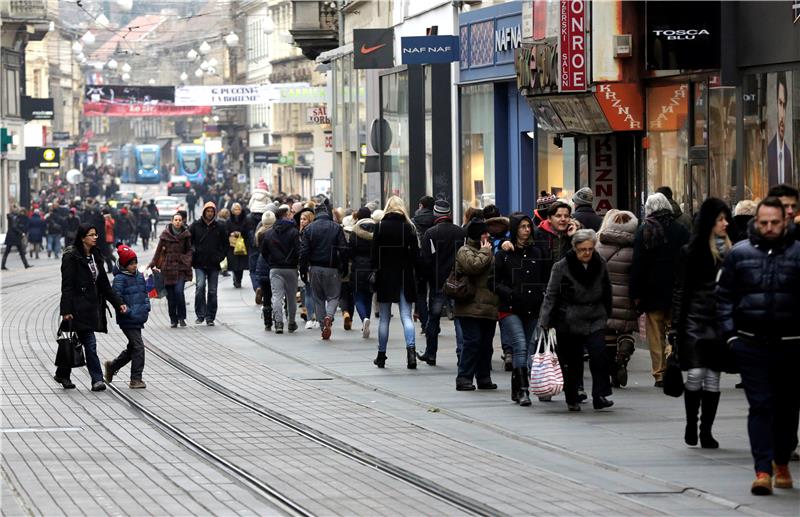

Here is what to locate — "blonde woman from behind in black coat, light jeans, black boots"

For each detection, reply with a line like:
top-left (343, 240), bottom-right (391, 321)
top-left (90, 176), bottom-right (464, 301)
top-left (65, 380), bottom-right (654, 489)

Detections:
top-left (372, 196), bottom-right (419, 369)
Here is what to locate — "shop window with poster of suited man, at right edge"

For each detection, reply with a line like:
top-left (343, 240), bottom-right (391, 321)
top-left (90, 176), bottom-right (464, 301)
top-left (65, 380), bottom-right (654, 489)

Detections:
top-left (742, 69), bottom-right (800, 200)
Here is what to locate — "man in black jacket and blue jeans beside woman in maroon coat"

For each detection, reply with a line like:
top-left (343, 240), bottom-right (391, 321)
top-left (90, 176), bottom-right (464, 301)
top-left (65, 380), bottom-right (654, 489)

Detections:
top-left (189, 202), bottom-right (229, 326)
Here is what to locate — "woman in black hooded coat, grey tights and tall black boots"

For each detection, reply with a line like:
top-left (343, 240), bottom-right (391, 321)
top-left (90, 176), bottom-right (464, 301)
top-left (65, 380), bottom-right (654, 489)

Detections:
top-left (669, 198), bottom-right (734, 449)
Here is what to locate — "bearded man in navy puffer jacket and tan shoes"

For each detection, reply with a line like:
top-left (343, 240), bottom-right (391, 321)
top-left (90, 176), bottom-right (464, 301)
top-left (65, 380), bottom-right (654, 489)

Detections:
top-left (717, 197), bottom-right (800, 495)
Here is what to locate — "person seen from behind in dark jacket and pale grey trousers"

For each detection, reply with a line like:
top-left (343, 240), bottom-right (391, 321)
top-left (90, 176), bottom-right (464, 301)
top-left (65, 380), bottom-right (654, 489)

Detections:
top-left (261, 208), bottom-right (300, 334)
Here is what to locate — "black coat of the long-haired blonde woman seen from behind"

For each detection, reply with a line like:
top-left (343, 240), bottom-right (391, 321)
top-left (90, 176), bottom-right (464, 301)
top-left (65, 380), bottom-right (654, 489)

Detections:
top-left (372, 212), bottom-right (419, 303)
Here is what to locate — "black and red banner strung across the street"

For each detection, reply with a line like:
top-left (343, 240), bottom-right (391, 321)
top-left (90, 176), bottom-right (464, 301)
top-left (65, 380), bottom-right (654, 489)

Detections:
top-left (83, 85), bottom-right (211, 117)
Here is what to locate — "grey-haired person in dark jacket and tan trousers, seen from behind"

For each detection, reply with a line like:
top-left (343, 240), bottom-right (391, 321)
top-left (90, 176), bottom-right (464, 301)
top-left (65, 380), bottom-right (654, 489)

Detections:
top-left (630, 192), bottom-right (689, 387)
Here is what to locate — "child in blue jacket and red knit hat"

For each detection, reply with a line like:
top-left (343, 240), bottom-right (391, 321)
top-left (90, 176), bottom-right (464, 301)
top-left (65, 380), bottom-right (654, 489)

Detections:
top-left (105, 245), bottom-right (150, 389)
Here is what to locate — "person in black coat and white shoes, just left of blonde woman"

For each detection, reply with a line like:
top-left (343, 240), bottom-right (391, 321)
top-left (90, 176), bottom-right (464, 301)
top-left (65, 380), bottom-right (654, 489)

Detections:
top-left (348, 207), bottom-right (378, 339)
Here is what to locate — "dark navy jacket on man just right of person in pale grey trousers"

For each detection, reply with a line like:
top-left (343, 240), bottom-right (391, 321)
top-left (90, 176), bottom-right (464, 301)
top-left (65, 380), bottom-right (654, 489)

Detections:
top-left (300, 211), bottom-right (347, 273)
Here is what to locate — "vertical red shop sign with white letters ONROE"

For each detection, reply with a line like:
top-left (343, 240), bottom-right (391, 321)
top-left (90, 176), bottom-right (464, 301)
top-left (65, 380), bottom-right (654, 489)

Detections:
top-left (559, 0), bottom-right (587, 92)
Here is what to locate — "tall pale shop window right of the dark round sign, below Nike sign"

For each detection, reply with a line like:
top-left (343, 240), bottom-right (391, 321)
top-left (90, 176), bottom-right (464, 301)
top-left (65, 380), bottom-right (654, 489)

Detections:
top-left (381, 71), bottom-right (414, 207)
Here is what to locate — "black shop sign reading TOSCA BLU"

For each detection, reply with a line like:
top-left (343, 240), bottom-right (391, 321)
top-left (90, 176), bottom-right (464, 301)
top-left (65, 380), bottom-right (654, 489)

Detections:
top-left (645, 1), bottom-right (722, 70)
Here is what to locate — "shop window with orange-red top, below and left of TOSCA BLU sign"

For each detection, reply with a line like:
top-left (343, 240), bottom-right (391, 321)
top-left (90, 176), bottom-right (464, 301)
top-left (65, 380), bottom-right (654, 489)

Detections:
top-left (646, 84), bottom-right (690, 213)
